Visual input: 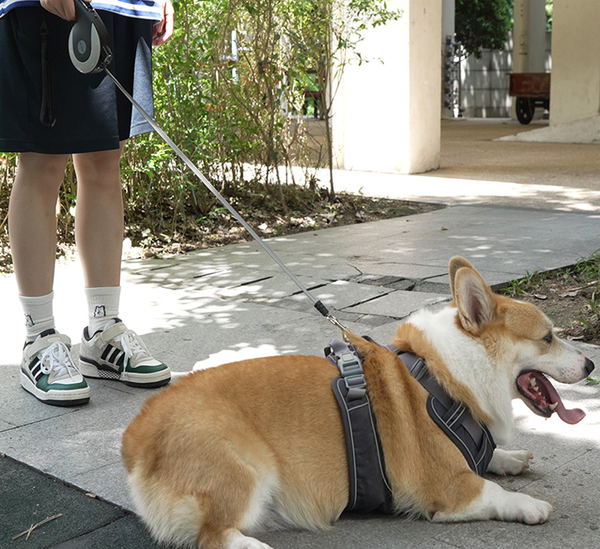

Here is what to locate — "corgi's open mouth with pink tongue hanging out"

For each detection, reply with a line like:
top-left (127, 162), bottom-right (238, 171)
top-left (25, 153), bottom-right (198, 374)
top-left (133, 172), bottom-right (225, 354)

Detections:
top-left (517, 370), bottom-right (585, 425)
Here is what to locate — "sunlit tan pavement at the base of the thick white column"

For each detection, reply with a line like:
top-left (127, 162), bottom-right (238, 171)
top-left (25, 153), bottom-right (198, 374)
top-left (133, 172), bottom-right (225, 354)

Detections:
top-left (328, 119), bottom-right (600, 212)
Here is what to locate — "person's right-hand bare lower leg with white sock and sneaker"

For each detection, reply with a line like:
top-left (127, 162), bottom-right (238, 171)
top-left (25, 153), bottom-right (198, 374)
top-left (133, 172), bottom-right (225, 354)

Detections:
top-left (74, 143), bottom-right (171, 387)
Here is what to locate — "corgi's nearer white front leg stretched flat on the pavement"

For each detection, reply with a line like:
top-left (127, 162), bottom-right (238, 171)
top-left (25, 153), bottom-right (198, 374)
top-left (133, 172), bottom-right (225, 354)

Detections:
top-left (433, 480), bottom-right (553, 524)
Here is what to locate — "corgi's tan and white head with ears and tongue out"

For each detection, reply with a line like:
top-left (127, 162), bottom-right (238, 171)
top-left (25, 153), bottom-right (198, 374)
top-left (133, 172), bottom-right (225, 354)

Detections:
top-left (449, 257), bottom-right (594, 423)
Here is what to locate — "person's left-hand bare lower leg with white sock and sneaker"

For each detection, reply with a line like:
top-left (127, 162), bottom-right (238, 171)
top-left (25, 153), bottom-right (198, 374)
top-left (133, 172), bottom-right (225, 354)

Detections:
top-left (9, 153), bottom-right (90, 406)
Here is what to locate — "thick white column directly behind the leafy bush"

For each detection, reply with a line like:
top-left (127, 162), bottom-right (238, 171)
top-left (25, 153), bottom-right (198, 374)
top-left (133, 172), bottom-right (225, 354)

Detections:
top-left (332, 0), bottom-right (442, 173)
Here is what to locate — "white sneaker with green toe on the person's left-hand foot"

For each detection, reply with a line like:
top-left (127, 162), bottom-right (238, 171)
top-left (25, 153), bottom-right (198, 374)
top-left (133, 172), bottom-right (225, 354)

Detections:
top-left (21, 330), bottom-right (90, 406)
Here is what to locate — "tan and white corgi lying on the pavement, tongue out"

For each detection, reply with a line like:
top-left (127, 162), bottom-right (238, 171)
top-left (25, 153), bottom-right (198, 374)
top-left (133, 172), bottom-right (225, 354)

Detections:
top-left (121, 257), bottom-right (594, 549)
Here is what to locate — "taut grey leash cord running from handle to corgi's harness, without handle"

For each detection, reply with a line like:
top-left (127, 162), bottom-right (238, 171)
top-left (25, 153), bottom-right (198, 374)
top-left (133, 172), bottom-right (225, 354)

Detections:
top-left (104, 67), bottom-right (347, 332)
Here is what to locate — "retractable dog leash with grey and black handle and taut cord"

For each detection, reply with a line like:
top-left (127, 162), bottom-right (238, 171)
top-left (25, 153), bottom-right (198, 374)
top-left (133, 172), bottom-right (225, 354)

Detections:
top-left (68, 0), bottom-right (348, 334)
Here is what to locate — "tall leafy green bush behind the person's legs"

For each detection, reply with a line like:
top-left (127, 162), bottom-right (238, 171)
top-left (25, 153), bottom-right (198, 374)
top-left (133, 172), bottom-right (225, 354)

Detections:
top-left (0, 0), bottom-right (399, 266)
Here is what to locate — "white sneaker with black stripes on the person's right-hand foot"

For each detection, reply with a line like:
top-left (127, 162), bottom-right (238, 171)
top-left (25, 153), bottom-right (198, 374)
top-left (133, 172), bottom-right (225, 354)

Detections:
top-left (79, 318), bottom-right (171, 387)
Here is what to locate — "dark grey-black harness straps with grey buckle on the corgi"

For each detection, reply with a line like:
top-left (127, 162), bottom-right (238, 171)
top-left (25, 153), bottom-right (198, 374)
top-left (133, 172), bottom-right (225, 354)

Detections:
top-left (325, 337), bottom-right (496, 513)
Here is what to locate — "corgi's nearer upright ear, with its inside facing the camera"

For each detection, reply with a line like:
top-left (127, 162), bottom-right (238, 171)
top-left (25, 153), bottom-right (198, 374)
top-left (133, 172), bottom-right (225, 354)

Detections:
top-left (453, 265), bottom-right (496, 335)
